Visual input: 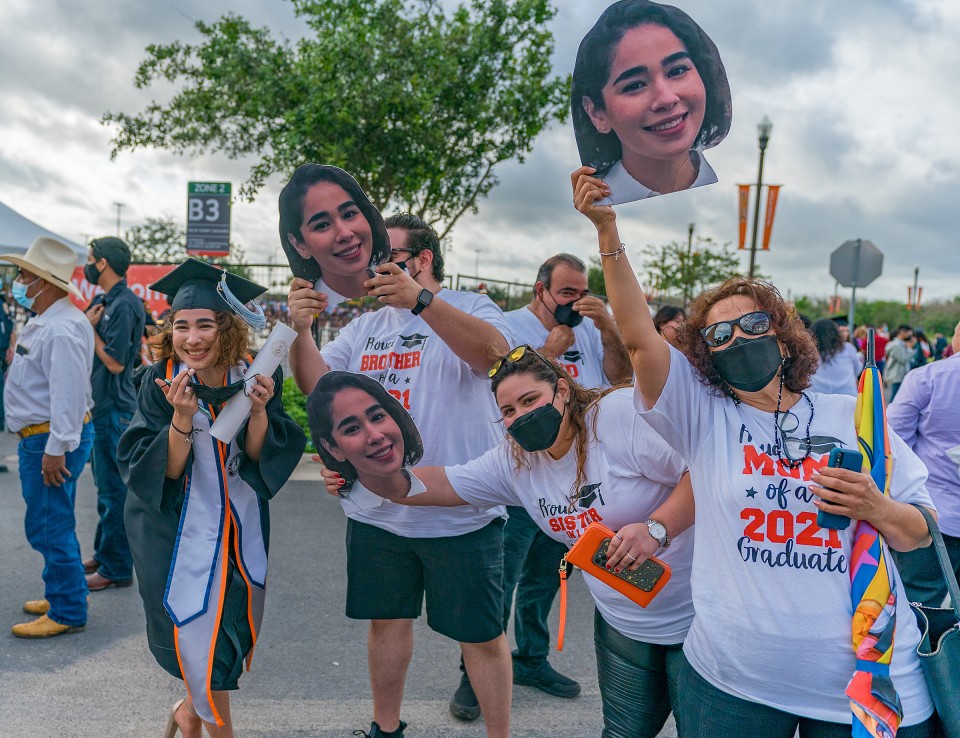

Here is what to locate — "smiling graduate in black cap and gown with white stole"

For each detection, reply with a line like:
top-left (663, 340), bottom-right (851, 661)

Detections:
top-left (118, 259), bottom-right (306, 738)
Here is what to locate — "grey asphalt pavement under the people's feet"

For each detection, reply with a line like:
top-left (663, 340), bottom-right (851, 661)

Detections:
top-left (0, 433), bottom-right (676, 738)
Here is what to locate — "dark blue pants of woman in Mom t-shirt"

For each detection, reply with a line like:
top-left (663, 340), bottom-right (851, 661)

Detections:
top-left (677, 659), bottom-right (938, 738)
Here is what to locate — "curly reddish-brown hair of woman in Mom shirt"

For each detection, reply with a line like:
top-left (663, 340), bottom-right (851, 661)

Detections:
top-left (680, 277), bottom-right (820, 398)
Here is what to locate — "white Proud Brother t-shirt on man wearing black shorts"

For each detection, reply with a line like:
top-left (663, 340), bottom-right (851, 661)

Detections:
top-left (321, 289), bottom-right (509, 538)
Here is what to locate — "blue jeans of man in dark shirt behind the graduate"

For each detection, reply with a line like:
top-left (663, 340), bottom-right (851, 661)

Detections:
top-left (91, 412), bottom-right (133, 582)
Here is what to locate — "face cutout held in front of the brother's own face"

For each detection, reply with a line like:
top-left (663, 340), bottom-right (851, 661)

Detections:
top-left (279, 164), bottom-right (390, 307)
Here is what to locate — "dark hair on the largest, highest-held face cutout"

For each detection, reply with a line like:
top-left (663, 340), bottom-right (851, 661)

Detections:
top-left (570, 0), bottom-right (733, 177)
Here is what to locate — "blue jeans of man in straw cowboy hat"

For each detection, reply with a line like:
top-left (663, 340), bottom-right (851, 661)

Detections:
top-left (17, 423), bottom-right (93, 626)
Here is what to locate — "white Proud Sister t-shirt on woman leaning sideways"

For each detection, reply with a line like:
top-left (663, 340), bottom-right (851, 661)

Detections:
top-left (446, 389), bottom-right (693, 644)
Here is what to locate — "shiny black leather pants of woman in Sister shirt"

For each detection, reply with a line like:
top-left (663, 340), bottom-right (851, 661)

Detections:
top-left (592, 608), bottom-right (684, 738)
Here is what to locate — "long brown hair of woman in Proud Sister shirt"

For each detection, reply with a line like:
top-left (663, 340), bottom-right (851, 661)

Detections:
top-left (490, 346), bottom-right (619, 502)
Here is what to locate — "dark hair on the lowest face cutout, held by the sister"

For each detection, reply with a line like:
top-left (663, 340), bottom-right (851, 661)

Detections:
top-left (307, 371), bottom-right (423, 493)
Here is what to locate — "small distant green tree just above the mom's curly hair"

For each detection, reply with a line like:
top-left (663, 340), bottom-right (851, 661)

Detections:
top-left (643, 236), bottom-right (748, 301)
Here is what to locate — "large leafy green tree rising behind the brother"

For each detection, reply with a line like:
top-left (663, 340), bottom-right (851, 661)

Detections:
top-left (103, 0), bottom-right (569, 238)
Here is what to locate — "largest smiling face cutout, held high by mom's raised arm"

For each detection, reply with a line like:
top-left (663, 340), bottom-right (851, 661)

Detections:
top-left (570, 0), bottom-right (733, 205)
